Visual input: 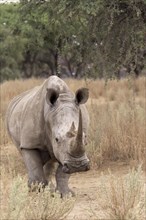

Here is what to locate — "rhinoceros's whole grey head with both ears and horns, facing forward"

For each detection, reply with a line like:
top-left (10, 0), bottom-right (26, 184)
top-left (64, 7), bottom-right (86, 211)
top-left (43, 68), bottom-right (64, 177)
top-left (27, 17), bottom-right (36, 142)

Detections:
top-left (45, 88), bottom-right (89, 173)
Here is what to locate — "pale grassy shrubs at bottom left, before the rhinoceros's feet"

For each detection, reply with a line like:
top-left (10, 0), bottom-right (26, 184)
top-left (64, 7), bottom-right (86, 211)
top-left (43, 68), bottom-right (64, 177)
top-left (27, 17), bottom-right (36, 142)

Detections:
top-left (0, 168), bottom-right (75, 220)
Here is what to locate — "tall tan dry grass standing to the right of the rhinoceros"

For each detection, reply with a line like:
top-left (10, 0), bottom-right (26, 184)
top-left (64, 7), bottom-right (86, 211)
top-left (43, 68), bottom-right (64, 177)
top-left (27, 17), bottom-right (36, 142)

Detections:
top-left (88, 78), bottom-right (146, 168)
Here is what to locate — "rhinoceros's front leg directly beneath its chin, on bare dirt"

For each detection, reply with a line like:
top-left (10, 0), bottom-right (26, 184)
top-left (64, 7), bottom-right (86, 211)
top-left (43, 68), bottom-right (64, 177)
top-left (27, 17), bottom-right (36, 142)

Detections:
top-left (56, 164), bottom-right (75, 197)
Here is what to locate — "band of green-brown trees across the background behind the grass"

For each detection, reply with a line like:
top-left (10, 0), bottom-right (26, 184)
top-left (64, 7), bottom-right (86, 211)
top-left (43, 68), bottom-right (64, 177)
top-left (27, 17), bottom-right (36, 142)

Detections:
top-left (0, 0), bottom-right (146, 80)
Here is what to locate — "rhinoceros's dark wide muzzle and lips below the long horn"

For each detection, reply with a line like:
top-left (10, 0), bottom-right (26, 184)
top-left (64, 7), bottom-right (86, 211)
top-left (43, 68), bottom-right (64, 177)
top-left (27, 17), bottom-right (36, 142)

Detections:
top-left (62, 160), bottom-right (90, 174)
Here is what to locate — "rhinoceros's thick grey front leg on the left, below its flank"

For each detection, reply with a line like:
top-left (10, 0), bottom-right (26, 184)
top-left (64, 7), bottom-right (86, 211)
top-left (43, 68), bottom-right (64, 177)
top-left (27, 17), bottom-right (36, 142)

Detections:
top-left (21, 149), bottom-right (48, 187)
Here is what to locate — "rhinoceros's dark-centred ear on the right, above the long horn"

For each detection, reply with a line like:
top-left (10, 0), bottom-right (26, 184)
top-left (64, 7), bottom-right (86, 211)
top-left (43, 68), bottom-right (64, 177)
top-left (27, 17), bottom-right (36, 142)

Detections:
top-left (75, 88), bottom-right (89, 104)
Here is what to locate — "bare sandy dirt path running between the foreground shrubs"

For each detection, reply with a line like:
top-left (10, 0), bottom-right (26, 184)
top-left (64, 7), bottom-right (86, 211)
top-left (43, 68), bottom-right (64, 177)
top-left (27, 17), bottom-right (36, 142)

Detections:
top-left (66, 162), bottom-right (137, 220)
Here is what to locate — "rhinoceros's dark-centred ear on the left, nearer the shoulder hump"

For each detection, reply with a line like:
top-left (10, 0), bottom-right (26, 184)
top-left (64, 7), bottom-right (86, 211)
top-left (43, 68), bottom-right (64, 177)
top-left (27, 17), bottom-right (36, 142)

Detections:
top-left (46, 88), bottom-right (59, 105)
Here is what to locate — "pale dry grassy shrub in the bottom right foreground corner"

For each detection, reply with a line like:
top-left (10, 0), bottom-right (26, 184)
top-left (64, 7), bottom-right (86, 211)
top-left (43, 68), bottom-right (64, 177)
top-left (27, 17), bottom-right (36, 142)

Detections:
top-left (91, 166), bottom-right (146, 220)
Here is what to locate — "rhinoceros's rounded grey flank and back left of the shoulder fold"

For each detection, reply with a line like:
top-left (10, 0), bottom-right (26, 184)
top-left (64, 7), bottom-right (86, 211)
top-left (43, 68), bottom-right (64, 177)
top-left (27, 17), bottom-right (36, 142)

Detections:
top-left (6, 83), bottom-right (45, 148)
